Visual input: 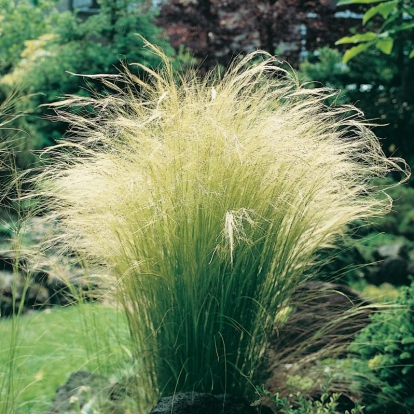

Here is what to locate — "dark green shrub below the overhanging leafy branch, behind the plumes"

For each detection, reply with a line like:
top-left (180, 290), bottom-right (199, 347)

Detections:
top-left (300, 47), bottom-right (414, 166)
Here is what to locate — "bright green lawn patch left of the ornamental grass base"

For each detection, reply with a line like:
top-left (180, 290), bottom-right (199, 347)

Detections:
top-left (0, 304), bottom-right (128, 414)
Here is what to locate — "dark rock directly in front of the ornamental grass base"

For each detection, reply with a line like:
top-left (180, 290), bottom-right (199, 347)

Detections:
top-left (150, 392), bottom-right (273, 414)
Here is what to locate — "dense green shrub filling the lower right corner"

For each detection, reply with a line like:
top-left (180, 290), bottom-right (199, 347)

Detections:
top-left (350, 284), bottom-right (414, 414)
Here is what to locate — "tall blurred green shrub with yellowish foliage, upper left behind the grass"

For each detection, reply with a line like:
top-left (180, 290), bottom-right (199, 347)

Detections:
top-left (0, 0), bottom-right (178, 151)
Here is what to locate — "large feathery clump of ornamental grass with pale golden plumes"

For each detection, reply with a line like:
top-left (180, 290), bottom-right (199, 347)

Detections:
top-left (34, 43), bottom-right (399, 406)
